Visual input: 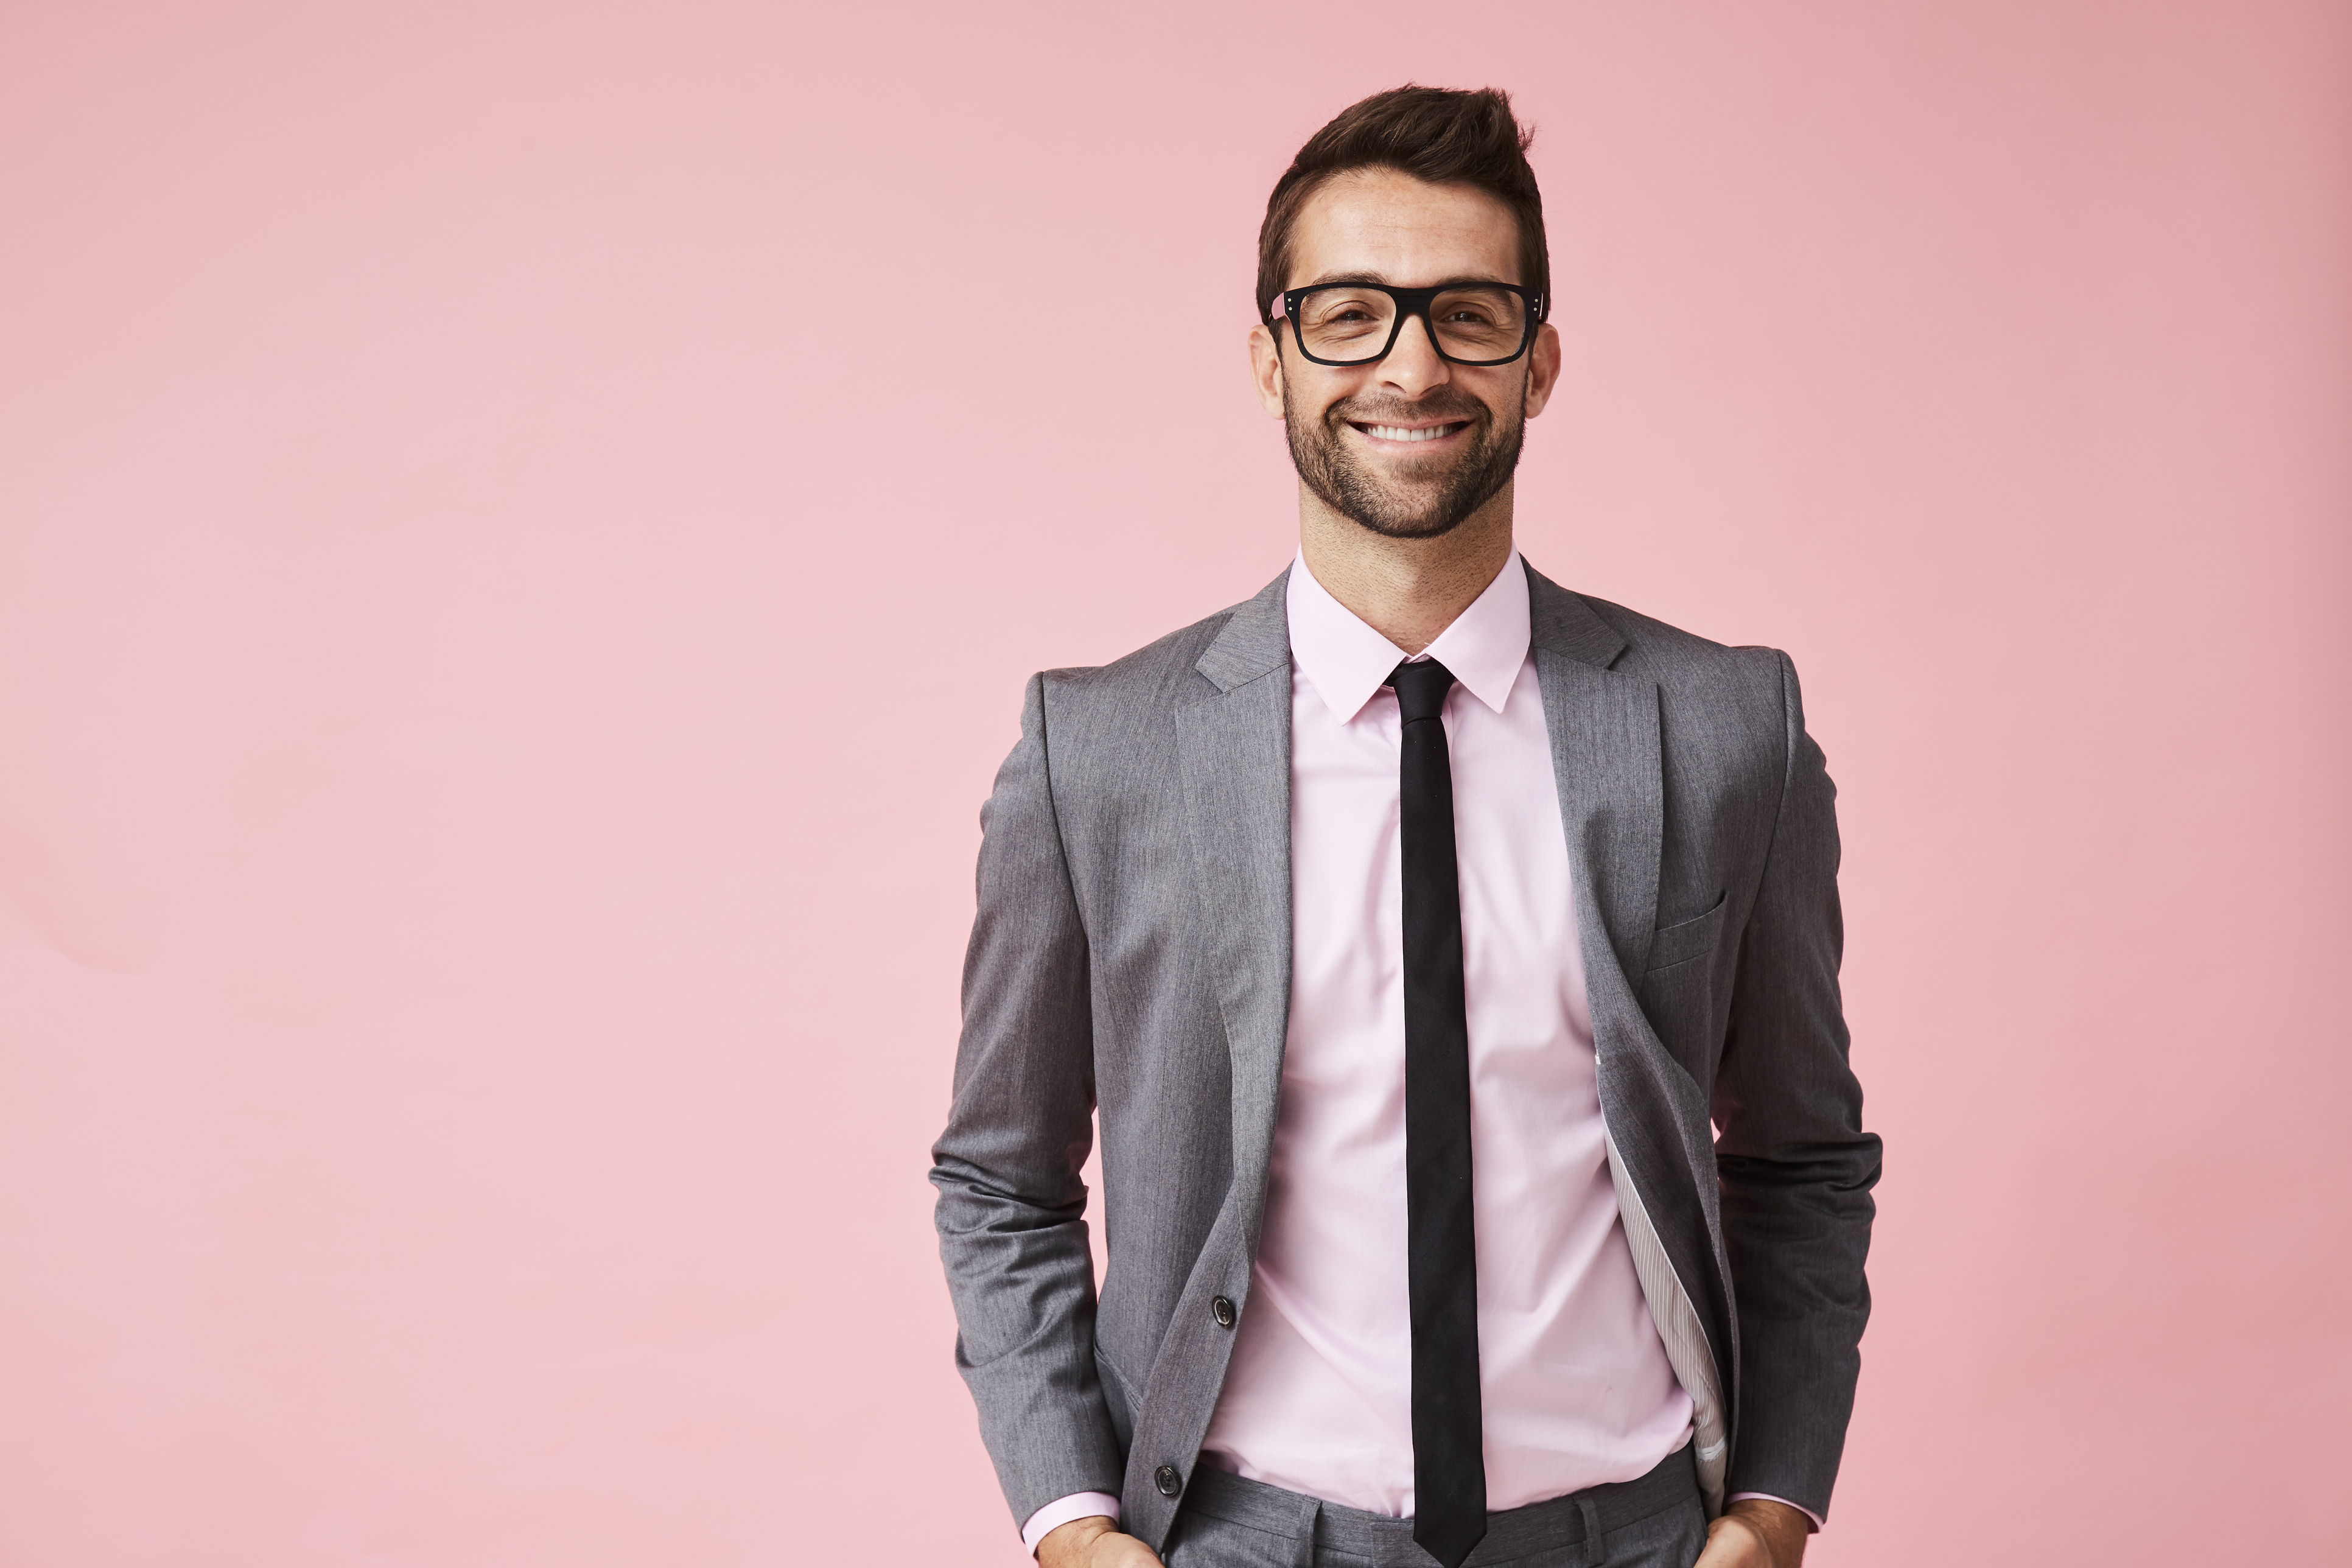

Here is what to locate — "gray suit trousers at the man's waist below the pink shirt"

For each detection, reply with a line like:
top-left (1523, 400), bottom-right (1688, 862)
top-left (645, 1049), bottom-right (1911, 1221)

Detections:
top-left (1164, 1443), bottom-right (1707, 1568)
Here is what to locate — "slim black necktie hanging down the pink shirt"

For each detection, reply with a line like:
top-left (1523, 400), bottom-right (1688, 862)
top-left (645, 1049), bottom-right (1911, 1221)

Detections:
top-left (1388, 660), bottom-right (1486, 1568)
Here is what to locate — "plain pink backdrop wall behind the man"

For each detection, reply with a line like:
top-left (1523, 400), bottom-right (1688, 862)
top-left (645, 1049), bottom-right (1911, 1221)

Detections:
top-left (0, 0), bottom-right (2352, 1568)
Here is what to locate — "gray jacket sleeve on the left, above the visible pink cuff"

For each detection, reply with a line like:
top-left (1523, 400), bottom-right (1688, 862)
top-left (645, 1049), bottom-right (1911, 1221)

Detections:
top-left (931, 677), bottom-right (1124, 1528)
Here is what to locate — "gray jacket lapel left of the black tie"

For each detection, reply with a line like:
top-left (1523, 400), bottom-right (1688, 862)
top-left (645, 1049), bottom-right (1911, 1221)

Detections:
top-left (1176, 573), bottom-right (1291, 1251)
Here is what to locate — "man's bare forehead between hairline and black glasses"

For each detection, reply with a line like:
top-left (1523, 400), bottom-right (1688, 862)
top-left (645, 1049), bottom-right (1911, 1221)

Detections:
top-left (1284, 169), bottom-right (1531, 289)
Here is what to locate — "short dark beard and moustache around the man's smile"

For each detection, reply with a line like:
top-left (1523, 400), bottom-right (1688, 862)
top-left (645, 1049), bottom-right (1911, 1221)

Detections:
top-left (1282, 385), bottom-right (1527, 538)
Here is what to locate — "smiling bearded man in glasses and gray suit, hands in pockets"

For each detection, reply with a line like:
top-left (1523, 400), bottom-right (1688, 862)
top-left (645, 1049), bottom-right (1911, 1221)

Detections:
top-left (931, 87), bottom-right (1879, 1568)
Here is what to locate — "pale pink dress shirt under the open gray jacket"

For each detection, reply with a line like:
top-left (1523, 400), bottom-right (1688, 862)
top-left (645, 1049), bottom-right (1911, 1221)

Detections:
top-left (1021, 553), bottom-right (1806, 1549)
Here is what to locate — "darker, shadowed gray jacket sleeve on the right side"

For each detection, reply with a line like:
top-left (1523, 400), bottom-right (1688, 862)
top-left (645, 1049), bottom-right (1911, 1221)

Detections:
top-left (1712, 654), bottom-right (1879, 1516)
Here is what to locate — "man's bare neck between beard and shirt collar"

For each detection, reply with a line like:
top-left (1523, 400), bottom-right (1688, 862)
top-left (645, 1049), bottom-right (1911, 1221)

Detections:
top-left (1298, 485), bottom-right (1513, 654)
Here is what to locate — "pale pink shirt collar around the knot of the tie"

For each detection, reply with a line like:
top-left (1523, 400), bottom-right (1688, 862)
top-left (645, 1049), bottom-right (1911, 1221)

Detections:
top-left (1284, 550), bottom-right (1531, 724)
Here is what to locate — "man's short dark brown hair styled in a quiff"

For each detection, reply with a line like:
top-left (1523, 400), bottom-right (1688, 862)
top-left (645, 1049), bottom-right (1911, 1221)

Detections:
top-left (1256, 82), bottom-right (1552, 324)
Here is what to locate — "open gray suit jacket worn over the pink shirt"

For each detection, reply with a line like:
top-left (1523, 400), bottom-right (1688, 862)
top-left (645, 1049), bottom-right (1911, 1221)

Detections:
top-left (931, 569), bottom-right (1879, 1547)
